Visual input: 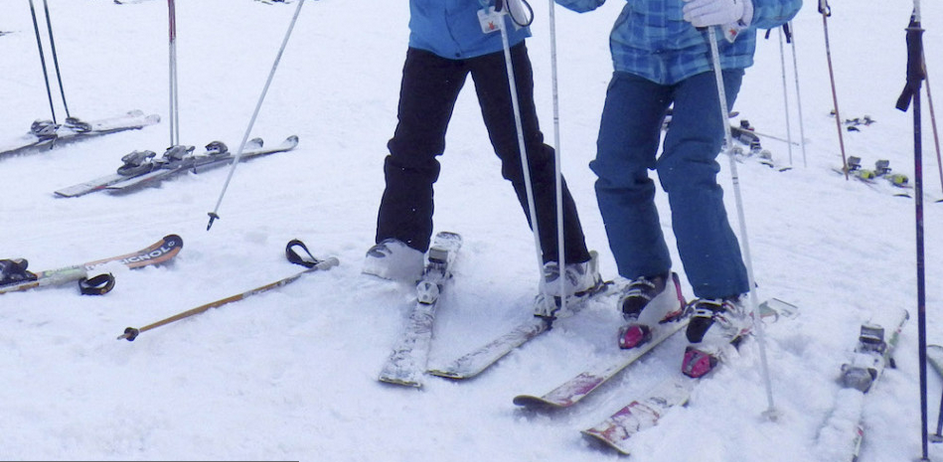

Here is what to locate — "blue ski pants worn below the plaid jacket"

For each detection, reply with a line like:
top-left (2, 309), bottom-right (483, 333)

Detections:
top-left (590, 69), bottom-right (749, 298)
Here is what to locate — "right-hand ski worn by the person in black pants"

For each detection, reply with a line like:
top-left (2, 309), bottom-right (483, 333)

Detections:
top-left (429, 276), bottom-right (611, 380)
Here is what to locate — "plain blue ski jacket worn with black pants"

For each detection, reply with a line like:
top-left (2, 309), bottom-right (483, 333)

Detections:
top-left (409, 0), bottom-right (536, 59)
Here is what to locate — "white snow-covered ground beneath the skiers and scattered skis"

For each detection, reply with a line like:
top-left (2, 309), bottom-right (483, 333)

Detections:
top-left (0, 0), bottom-right (943, 462)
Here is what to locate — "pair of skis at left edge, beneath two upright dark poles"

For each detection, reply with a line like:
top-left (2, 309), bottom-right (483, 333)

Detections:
top-left (0, 110), bottom-right (160, 158)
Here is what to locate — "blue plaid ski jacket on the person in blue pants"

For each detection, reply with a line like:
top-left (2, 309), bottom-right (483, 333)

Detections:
top-left (555, 0), bottom-right (802, 85)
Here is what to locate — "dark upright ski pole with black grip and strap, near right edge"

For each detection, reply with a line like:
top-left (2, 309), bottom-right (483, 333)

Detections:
top-left (897, 8), bottom-right (930, 461)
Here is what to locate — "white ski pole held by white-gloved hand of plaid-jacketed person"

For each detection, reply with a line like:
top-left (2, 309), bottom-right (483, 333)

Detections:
top-left (707, 27), bottom-right (778, 420)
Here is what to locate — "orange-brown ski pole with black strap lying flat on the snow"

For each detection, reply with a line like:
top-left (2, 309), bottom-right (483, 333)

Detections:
top-left (118, 239), bottom-right (339, 342)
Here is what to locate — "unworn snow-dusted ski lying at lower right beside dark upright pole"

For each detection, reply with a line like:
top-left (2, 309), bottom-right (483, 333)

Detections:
top-left (816, 309), bottom-right (910, 462)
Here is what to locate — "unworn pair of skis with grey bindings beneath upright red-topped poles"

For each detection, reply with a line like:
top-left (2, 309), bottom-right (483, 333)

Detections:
top-left (56, 135), bottom-right (298, 197)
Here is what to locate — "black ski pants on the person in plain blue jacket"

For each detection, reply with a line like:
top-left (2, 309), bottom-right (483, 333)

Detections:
top-left (376, 43), bottom-right (589, 263)
